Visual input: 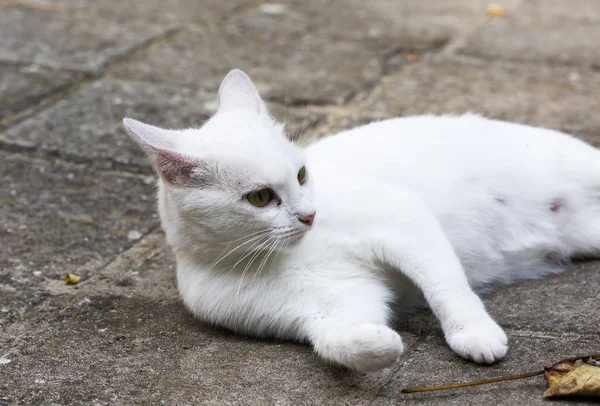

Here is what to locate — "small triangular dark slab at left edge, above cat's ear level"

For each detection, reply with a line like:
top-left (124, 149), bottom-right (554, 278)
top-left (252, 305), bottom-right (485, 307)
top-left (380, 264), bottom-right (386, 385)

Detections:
top-left (0, 64), bottom-right (80, 123)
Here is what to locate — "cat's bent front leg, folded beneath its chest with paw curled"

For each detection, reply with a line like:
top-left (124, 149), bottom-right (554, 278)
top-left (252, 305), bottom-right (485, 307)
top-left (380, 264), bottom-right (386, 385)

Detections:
top-left (306, 281), bottom-right (404, 372)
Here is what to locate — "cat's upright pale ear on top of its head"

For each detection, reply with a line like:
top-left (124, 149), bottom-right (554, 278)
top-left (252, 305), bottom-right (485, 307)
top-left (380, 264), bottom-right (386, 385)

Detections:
top-left (219, 69), bottom-right (266, 114)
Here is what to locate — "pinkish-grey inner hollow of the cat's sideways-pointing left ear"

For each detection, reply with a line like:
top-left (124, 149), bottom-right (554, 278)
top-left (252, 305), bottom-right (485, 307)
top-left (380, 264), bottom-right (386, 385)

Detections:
top-left (154, 150), bottom-right (203, 186)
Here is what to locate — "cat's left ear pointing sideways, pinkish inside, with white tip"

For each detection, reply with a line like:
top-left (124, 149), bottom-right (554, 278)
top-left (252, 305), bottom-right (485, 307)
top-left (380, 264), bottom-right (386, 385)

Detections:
top-left (123, 118), bottom-right (214, 186)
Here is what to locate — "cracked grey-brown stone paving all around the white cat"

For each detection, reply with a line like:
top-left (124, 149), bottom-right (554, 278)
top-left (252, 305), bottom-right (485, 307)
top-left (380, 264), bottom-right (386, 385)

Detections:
top-left (0, 0), bottom-right (600, 405)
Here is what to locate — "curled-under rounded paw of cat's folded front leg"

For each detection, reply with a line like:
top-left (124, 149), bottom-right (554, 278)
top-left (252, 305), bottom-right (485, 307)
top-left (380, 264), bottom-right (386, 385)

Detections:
top-left (335, 324), bottom-right (404, 372)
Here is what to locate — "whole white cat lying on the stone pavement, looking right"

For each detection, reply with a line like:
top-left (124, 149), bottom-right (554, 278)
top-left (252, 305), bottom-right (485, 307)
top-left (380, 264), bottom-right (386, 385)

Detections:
top-left (124, 70), bottom-right (600, 371)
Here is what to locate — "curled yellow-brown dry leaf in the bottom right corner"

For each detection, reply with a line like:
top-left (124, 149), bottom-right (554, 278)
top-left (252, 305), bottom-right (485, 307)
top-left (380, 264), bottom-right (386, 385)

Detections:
top-left (544, 356), bottom-right (600, 397)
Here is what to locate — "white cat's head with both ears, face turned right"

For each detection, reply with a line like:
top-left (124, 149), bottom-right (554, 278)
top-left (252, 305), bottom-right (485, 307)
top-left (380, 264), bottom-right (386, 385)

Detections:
top-left (123, 70), bottom-right (315, 264)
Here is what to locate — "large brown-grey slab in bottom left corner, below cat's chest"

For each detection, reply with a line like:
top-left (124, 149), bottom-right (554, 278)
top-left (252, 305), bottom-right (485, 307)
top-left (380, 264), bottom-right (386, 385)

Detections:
top-left (0, 294), bottom-right (404, 405)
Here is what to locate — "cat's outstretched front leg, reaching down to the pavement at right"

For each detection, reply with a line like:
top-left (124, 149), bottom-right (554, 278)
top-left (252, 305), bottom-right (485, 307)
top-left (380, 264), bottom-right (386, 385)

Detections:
top-left (370, 205), bottom-right (507, 363)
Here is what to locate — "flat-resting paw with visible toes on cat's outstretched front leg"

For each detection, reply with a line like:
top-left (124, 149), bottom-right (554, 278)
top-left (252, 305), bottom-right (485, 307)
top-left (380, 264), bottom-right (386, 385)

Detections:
top-left (446, 319), bottom-right (508, 364)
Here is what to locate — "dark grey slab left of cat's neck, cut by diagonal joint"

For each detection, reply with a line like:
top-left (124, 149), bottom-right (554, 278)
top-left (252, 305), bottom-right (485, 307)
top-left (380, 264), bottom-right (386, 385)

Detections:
top-left (0, 153), bottom-right (158, 324)
